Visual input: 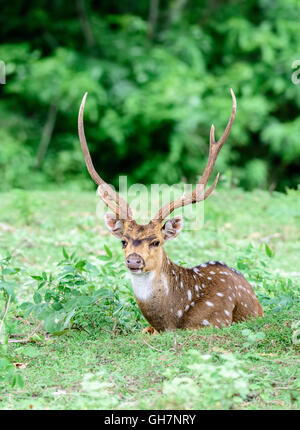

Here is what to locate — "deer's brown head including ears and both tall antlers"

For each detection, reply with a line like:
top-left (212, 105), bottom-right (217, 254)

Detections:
top-left (78, 90), bottom-right (236, 273)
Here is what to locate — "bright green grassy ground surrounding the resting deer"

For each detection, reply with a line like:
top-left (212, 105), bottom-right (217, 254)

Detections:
top-left (0, 190), bottom-right (300, 409)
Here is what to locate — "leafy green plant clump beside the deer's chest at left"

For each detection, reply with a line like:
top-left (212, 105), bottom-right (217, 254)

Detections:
top-left (20, 245), bottom-right (142, 335)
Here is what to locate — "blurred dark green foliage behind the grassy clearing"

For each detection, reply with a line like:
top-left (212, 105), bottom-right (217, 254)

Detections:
top-left (0, 0), bottom-right (300, 191)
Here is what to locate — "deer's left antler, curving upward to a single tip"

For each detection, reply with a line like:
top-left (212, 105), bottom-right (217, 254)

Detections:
top-left (78, 93), bottom-right (132, 219)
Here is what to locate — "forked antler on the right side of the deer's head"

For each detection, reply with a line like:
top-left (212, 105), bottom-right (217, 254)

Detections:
top-left (154, 88), bottom-right (237, 220)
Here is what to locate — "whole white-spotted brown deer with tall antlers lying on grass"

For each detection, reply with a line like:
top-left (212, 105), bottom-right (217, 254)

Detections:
top-left (78, 90), bottom-right (263, 331)
